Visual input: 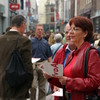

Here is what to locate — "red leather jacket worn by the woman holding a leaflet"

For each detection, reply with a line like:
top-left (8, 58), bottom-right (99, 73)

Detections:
top-left (51, 42), bottom-right (100, 100)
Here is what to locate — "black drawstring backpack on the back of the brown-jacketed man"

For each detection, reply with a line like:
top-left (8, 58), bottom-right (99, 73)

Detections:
top-left (6, 35), bottom-right (28, 87)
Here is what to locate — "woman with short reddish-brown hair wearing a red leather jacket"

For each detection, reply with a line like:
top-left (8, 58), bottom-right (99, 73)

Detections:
top-left (44, 16), bottom-right (100, 100)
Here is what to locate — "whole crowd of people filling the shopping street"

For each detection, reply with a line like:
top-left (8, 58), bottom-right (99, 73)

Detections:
top-left (0, 15), bottom-right (100, 100)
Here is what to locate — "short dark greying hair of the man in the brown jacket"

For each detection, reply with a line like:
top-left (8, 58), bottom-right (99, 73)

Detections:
top-left (11, 15), bottom-right (26, 28)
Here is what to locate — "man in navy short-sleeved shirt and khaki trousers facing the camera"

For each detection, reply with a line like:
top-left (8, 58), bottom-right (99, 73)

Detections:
top-left (31, 24), bottom-right (52, 100)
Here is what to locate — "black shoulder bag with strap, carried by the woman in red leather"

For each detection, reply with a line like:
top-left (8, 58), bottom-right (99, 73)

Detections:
top-left (84, 46), bottom-right (99, 100)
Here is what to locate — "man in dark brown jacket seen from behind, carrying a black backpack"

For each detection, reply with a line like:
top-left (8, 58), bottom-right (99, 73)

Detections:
top-left (0, 15), bottom-right (33, 100)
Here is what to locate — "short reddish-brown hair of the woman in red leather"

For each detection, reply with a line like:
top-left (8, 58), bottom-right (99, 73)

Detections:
top-left (69, 16), bottom-right (93, 42)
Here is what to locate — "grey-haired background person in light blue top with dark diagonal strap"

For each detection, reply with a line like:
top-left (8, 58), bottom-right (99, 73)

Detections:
top-left (51, 33), bottom-right (63, 59)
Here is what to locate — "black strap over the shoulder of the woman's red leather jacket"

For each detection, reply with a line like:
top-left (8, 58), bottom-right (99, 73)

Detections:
top-left (83, 46), bottom-right (95, 78)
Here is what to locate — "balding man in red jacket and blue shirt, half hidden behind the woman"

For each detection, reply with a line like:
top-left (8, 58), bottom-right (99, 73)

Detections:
top-left (51, 23), bottom-right (76, 100)
